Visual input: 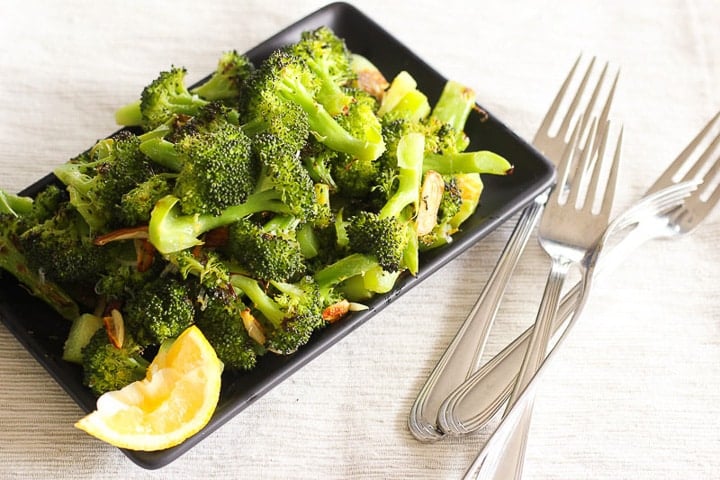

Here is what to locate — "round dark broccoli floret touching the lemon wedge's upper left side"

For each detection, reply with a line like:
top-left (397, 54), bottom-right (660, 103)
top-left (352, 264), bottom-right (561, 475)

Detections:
top-left (82, 328), bottom-right (150, 396)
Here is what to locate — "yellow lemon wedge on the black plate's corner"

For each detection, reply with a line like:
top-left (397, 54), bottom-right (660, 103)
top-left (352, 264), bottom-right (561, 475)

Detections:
top-left (75, 326), bottom-right (223, 451)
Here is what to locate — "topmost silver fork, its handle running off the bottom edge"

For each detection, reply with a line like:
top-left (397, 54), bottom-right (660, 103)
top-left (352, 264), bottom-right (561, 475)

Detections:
top-left (470, 114), bottom-right (622, 480)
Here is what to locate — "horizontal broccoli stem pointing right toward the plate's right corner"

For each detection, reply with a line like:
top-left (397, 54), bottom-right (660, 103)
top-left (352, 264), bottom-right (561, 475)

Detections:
top-left (422, 150), bottom-right (512, 175)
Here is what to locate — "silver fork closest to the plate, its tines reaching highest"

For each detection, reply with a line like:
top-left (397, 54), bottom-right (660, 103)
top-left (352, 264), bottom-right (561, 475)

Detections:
top-left (408, 56), bottom-right (617, 442)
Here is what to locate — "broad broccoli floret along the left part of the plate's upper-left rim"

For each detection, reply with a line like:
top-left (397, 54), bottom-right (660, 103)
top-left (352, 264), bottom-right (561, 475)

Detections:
top-left (54, 130), bottom-right (156, 232)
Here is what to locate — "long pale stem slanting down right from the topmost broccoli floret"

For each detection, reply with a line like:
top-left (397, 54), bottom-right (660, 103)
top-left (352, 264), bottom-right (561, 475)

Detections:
top-left (279, 79), bottom-right (385, 161)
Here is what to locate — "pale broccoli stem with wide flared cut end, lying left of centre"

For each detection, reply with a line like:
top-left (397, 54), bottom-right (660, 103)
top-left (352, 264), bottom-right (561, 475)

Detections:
top-left (148, 190), bottom-right (287, 254)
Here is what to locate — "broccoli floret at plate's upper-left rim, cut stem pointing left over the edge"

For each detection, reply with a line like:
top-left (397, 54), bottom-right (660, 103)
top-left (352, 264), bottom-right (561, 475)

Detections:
top-left (115, 66), bottom-right (207, 131)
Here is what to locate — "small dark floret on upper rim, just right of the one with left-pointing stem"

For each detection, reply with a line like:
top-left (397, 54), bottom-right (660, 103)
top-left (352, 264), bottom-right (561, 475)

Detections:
top-left (191, 50), bottom-right (255, 100)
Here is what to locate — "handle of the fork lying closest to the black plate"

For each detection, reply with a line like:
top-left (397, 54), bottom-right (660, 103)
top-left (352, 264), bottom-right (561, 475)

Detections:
top-left (408, 195), bottom-right (546, 442)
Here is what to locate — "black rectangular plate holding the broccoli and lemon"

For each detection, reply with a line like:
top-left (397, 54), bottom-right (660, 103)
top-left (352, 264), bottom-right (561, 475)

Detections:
top-left (0, 3), bottom-right (555, 469)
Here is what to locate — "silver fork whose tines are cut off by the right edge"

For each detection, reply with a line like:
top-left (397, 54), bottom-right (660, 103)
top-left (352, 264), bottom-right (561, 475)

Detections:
top-left (438, 112), bottom-right (720, 434)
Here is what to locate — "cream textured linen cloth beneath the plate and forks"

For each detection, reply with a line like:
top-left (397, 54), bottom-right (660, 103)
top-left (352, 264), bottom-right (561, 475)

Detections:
top-left (0, 0), bottom-right (720, 480)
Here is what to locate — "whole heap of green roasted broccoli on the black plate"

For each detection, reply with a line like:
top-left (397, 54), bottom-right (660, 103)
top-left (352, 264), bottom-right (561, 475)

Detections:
top-left (0, 27), bottom-right (512, 394)
